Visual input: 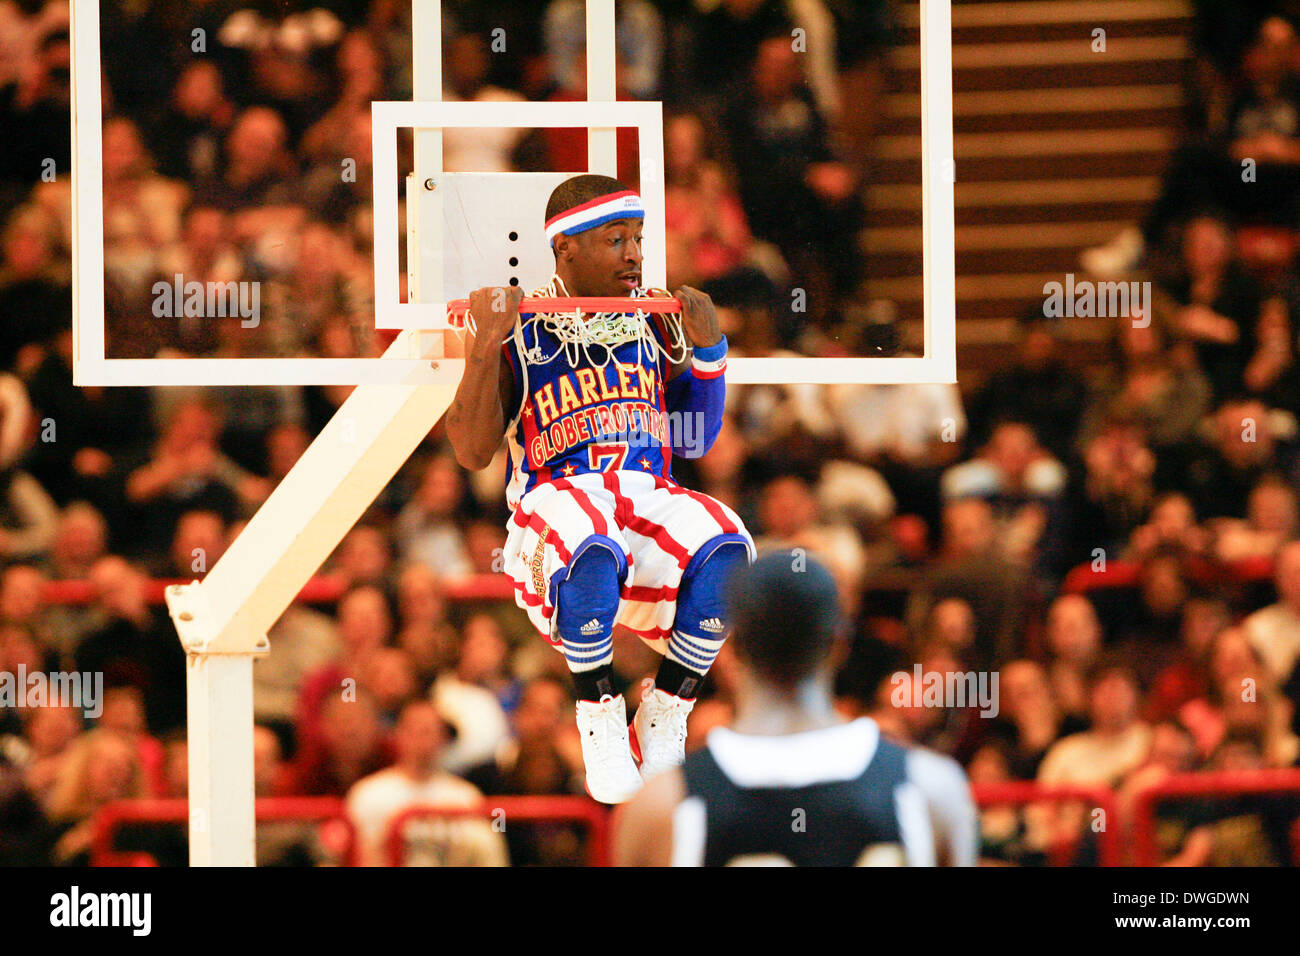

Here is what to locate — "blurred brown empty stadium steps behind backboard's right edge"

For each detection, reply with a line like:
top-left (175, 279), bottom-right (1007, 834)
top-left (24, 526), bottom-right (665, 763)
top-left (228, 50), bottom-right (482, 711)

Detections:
top-left (862, 0), bottom-right (1191, 389)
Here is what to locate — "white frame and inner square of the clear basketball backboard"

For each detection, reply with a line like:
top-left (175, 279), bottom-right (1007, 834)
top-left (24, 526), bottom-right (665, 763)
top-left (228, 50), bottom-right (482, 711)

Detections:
top-left (73, 0), bottom-right (956, 385)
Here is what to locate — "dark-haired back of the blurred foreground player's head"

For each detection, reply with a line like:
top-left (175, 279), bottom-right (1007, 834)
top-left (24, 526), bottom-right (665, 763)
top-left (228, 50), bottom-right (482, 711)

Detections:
top-left (728, 548), bottom-right (841, 687)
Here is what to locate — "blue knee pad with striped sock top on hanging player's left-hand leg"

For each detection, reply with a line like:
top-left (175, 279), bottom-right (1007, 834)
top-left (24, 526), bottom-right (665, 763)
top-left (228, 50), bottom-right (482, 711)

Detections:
top-left (551, 535), bottom-right (628, 670)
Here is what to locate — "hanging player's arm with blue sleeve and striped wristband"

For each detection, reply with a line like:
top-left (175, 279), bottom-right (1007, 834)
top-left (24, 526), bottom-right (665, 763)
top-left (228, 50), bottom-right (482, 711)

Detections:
top-left (664, 286), bottom-right (727, 458)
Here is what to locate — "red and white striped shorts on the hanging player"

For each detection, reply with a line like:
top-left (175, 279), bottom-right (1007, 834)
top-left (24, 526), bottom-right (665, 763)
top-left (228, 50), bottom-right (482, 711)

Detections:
top-left (503, 471), bottom-right (757, 653)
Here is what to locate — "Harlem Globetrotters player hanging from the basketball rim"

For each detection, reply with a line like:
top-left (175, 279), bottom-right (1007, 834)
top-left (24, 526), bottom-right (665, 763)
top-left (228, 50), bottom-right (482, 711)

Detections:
top-left (447, 176), bottom-right (754, 804)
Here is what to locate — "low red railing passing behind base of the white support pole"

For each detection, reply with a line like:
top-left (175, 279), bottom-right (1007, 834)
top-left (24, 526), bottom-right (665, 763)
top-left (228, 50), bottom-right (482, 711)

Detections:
top-left (91, 797), bottom-right (356, 866)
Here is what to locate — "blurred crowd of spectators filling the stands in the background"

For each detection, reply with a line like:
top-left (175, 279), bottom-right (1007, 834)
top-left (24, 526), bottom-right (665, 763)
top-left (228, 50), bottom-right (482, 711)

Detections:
top-left (0, 0), bottom-right (1300, 864)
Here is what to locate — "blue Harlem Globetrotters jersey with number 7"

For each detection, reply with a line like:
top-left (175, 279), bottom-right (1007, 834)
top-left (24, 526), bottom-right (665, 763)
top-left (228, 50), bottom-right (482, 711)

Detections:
top-left (502, 291), bottom-right (672, 510)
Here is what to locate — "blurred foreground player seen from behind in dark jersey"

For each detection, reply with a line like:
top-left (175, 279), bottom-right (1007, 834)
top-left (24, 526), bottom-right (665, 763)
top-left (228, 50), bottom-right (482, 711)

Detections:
top-left (615, 551), bottom-right (976, 866)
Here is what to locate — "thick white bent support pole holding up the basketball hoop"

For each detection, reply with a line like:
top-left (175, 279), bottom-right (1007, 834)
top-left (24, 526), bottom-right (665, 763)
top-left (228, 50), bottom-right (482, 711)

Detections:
top-left (166, 330), bottom-right (456, 866)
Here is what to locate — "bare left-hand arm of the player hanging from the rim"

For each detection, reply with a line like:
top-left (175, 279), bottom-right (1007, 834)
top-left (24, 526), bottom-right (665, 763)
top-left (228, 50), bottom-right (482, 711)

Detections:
top-left (447, 286), bottom-right (524, 471)
